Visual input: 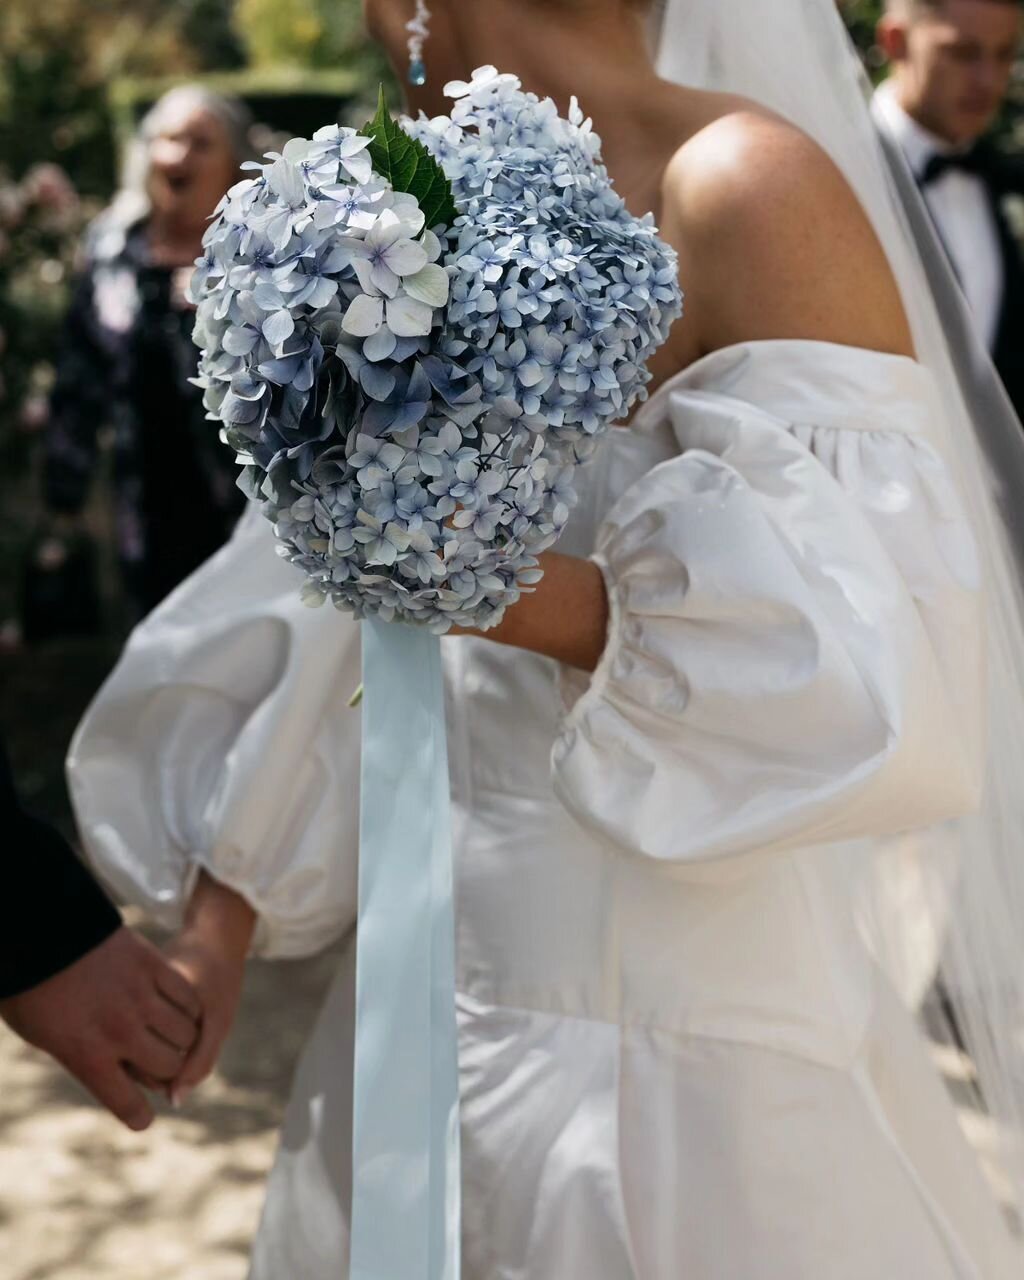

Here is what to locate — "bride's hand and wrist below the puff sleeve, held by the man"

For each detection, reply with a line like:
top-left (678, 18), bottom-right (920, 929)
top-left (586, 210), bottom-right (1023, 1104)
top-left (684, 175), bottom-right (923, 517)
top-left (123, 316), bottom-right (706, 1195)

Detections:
top-left (166, 872), bottom-right (256, 1106)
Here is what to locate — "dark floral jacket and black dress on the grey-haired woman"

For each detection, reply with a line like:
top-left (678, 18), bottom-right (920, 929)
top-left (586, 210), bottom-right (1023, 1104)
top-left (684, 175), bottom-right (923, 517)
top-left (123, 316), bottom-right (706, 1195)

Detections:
top-left (45, 220), bottom-right (244, 608)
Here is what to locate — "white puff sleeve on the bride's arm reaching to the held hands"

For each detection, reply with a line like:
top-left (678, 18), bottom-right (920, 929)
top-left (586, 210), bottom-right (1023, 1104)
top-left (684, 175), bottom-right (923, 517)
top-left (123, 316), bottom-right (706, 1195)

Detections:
top-left (68, 511), bottom-right (361, 956)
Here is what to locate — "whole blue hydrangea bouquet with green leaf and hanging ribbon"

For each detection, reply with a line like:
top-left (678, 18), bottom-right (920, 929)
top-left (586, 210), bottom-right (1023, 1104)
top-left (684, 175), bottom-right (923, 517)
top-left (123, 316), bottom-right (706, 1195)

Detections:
top-left (185, 67), bottom-right (681, 1280)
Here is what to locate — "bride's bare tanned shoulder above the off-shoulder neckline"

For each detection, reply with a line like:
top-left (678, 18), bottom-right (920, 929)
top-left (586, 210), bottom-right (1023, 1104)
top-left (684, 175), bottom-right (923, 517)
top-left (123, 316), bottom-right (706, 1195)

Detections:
top-left (660, 107), bottom-right (911, 353)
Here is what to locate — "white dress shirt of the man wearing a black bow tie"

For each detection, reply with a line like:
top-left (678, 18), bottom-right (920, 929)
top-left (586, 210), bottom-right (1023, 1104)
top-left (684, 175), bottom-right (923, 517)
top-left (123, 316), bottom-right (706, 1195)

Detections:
top-left (872, 81), bottom-right (1004, 351)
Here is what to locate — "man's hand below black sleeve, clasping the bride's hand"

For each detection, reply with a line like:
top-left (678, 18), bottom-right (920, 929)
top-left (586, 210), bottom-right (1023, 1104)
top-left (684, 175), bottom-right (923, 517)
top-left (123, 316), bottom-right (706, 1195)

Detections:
top-left (0, 928), bottom-right (201, 1130)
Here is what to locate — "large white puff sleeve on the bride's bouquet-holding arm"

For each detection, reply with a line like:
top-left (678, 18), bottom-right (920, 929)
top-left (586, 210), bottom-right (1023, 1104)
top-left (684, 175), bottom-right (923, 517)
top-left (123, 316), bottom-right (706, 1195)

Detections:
top-left (553, 396), bottom-right (983, 874)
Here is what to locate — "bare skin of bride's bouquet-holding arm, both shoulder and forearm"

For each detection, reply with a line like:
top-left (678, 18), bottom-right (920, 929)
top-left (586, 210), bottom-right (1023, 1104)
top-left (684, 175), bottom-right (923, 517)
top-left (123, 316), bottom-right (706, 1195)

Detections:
top-left (474, 114), bottom-right (914, 671)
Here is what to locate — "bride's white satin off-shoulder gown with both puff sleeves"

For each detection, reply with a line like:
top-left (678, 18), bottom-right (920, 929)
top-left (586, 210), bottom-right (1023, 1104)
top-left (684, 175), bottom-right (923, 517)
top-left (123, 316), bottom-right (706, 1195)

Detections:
top-left (69, 340), bottom-right (1024, 1280)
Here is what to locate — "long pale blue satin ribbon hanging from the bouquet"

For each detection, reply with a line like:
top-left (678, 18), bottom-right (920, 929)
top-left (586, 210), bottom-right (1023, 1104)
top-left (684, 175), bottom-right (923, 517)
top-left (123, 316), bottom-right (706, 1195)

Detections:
top-left (349, 620), bottom-right (460, 1280)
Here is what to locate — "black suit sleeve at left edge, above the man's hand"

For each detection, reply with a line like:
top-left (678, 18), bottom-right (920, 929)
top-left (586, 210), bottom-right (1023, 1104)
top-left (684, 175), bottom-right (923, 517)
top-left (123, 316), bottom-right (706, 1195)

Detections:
top-left (0, 739), bottom-right (120, 998)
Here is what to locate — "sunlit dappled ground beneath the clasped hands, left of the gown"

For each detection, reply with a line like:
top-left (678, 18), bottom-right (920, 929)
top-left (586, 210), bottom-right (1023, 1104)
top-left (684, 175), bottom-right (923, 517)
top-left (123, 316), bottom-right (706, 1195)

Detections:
top-left (0, 916), bottom-right (338, 1280)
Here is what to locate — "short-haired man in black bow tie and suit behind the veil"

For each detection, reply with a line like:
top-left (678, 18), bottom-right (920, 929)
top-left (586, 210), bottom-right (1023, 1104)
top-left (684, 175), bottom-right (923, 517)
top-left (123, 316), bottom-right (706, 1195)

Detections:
top-left (873, 0), bottom-right (1024, 415)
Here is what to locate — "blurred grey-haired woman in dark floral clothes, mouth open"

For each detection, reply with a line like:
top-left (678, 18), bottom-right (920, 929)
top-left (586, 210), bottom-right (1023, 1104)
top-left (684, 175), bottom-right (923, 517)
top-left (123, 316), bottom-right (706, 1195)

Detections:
top-left (46, 86), bottom-right (250, 613)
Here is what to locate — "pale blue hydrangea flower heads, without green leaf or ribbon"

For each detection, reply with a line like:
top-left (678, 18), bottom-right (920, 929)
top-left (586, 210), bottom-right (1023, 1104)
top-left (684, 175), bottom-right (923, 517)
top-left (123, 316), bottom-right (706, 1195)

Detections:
top-left (193, 68), bottom-right (681, 632)
